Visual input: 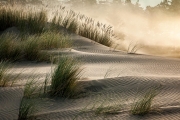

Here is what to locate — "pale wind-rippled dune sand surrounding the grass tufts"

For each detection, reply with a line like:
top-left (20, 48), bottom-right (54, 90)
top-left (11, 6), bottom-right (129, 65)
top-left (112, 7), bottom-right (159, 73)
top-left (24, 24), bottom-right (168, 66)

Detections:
top-left (0, 35), bottom-right (180, 120)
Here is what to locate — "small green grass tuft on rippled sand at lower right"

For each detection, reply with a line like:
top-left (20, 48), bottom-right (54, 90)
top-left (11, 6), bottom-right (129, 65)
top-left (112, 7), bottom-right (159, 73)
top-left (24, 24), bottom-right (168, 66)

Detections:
top-left (131, 89), bottom-right (157, 115)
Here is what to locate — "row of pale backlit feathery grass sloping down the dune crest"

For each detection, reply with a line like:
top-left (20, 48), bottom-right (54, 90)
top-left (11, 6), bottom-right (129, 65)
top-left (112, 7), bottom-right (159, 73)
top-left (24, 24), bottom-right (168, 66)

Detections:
top-left (52, 7), bottom-right (113, 47)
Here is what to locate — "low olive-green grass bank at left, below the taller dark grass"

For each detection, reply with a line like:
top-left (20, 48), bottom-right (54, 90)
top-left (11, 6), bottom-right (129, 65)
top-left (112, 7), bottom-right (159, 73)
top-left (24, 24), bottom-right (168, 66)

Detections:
top-left (0, 31), bottom-right (72, 61)
